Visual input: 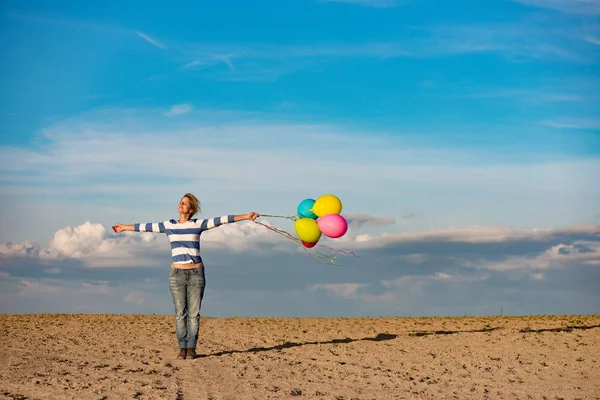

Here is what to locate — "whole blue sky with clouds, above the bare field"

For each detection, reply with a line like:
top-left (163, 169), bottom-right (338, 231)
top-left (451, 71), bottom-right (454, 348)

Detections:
top-left (0, 0), bottom-right (600, 316)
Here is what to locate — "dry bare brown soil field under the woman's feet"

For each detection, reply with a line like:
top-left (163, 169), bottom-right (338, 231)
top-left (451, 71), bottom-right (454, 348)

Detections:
top-left (0, 314), bottom-right (600, 400)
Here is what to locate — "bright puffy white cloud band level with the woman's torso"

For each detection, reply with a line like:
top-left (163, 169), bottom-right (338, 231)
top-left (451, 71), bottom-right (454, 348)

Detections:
top-left (0, 212), bottom-right (600, 272)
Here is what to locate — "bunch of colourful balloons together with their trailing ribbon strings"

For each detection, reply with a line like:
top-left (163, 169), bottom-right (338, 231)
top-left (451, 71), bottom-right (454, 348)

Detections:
top-left (254, 194), bottom-right (358, 265)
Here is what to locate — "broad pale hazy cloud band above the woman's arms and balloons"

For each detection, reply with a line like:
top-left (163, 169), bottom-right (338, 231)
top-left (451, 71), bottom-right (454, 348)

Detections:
top-left (0, 109), bottom-right (600, 248)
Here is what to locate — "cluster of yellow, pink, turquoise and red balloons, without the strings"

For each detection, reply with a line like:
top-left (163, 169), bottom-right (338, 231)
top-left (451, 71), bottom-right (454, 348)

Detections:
top-left (294, 194), bottom-right (348, 248)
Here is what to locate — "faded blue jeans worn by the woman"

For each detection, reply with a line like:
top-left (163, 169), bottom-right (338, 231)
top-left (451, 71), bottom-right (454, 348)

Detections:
top-left (169, 267), bottom-right (206, 349)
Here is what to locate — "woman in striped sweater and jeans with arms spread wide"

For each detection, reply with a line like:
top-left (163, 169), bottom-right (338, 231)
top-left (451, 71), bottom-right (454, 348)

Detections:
top-left (112, 193), bottom-right (259, 359)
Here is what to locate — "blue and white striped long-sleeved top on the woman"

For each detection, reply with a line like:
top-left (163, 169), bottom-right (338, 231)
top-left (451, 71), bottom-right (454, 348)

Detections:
top-left (133, 215), bottom-right (234, 264)
